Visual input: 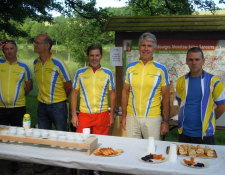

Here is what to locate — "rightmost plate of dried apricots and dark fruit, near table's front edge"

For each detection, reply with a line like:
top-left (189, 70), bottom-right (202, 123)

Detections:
top-left (181, 157), bottom-right (210, 169)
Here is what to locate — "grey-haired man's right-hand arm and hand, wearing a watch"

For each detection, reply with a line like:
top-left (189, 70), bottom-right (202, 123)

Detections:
top-left (160, 85), bottom-right (170, 135)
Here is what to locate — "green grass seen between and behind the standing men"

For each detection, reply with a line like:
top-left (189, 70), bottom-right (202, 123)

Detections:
top-left (0, 44), bottom-right (225, 145)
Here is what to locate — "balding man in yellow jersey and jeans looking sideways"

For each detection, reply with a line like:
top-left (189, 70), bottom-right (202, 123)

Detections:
top-left (34, 34), bottom-right (72, 174)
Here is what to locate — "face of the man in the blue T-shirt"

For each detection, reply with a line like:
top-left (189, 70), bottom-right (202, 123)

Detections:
top-left (186, 52), bottom-right (205, 77)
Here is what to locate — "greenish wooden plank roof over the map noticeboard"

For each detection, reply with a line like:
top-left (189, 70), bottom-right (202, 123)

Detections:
top-left (102, 15), bottom-right (225, 32)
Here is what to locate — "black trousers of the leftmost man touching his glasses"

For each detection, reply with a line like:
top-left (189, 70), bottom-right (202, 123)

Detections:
top-left (0, 106), bottom-right (26, 126)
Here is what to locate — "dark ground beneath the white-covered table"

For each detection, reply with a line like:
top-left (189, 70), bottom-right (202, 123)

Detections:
top-left (0, 159), bottom-right (127, 175)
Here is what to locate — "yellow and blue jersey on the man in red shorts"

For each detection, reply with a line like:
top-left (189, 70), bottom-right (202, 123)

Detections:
top-left (73, 66), bottom-right (114, 114)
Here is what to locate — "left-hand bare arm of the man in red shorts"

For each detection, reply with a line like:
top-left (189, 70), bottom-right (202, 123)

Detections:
top-left (70, 88), bottom-right (79, 127)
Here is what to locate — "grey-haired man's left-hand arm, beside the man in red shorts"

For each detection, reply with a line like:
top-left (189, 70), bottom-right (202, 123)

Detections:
top-left (122, 83), bottom-right (130, 130)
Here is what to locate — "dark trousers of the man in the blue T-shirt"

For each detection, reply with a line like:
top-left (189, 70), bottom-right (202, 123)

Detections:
top-left (178, 134), bottom-right (215, 145)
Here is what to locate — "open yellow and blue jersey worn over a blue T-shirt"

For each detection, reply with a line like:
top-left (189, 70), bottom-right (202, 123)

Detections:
top-left (176, 70), bottom-right (225, 137)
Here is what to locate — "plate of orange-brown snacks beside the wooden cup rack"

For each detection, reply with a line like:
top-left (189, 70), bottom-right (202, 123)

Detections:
top-left (93, 147), bottom-right (123, 157)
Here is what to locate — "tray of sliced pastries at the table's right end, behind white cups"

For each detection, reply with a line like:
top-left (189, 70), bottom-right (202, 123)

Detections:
top-left (166, 144), bottom-right (217, 158)
